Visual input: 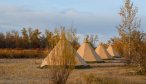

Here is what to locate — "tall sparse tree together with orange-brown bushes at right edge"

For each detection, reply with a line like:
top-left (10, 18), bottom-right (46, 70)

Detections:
top-left (109, 0), bottom-right (146, 74)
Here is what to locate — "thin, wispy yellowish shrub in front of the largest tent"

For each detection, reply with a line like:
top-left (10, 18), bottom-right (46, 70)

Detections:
top-left (48, 29), bottom-right (76, 84)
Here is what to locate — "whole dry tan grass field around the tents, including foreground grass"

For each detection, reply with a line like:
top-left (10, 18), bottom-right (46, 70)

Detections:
top-left (0, 59), bottom-right (146, 84)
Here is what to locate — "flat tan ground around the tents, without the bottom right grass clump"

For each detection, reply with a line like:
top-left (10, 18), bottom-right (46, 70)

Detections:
top-left (0, 59), bottom-right (146, 84)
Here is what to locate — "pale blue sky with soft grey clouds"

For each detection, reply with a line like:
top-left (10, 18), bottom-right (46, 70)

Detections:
top-left (0, 0), bottom-right (146, 41)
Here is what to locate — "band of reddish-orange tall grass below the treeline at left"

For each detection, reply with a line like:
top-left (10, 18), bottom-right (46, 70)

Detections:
top-left (0, 49), bottom-right (49, 58)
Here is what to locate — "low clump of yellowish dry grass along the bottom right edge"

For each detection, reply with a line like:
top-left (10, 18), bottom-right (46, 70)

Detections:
top-left (69, 74), bottom-right (146, 84)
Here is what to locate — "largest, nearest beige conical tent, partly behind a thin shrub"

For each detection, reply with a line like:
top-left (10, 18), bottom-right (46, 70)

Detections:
top-left (41, 33), bottom-right (88, 67)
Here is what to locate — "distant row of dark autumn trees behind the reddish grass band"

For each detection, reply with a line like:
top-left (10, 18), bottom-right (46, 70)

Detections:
top-left (0, 28), bottom-right (78, 49)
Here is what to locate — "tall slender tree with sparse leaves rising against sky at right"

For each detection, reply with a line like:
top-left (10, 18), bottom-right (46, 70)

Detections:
top-left (118, 0), bottom-right (140, 62)
